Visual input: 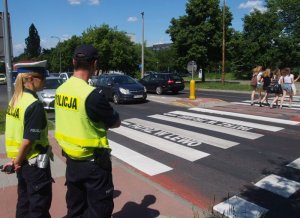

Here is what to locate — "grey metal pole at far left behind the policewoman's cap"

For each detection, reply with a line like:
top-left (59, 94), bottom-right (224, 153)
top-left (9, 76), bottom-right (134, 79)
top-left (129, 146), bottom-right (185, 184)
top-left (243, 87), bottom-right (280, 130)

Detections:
top-left (3, 0), bottom-right (13, 102)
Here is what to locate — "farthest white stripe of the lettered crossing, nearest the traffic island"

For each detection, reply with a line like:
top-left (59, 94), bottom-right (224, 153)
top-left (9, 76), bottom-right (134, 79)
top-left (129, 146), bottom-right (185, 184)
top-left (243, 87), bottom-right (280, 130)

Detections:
top-left (189, 108), bottom-right (300, 125)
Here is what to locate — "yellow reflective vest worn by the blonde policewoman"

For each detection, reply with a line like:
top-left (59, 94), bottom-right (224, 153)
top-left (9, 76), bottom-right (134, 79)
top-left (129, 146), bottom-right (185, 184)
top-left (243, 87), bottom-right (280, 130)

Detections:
top-left (5, 92), bottom-right (49, 160)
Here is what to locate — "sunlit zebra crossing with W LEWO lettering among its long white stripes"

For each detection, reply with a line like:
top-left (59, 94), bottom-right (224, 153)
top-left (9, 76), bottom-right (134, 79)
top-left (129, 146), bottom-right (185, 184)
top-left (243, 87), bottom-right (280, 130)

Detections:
top-left (110, 108), bottom-right (300, 176)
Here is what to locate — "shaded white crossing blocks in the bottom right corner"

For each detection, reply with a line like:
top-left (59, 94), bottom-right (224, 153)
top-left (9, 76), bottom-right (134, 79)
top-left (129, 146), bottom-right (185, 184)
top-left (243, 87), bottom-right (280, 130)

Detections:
top-left (213, 158), bottom-right (300, 218)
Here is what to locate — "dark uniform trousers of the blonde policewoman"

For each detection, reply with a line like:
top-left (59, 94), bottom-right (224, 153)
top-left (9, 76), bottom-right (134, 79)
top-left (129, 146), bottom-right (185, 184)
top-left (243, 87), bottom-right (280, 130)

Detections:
top-left (16, 163), bottom-right (53, 218)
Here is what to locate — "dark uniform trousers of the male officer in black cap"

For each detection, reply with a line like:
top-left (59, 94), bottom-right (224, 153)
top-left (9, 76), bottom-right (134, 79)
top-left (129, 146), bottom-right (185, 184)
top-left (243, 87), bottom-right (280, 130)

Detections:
top-left (66, 150), bottom-right (114, 218)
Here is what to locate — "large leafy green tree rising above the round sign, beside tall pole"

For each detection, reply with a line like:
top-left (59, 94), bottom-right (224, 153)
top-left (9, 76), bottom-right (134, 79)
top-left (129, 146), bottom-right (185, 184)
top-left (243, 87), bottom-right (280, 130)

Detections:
top-left (166, 0), bottom-right (232, 73)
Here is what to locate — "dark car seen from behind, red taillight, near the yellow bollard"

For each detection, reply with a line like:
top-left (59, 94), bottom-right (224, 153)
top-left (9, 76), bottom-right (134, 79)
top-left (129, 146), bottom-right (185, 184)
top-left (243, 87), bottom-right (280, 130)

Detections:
top-left (139, 73), bottom-right (184, 95)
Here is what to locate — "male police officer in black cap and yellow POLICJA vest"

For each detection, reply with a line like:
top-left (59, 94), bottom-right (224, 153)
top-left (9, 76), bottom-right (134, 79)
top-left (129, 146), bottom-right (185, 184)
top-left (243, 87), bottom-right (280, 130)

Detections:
top-left (55, 45), bottom-right (120, 218)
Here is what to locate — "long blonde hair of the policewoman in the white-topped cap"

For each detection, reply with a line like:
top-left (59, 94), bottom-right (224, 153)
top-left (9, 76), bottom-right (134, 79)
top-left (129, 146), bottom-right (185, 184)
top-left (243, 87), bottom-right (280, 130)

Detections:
top-left (10, 72), bottom-right (40, 107)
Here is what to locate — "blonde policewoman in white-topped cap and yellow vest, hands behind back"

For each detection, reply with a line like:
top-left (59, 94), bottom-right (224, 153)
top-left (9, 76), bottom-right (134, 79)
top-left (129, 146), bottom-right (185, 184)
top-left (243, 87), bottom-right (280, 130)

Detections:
top-left (2, 61), bottom-right (53, 218)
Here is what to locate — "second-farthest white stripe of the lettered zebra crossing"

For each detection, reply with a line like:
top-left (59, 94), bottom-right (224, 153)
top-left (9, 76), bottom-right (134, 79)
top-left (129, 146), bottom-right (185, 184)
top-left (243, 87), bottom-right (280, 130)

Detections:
top-left (170, 108), bottom-right (283, 132)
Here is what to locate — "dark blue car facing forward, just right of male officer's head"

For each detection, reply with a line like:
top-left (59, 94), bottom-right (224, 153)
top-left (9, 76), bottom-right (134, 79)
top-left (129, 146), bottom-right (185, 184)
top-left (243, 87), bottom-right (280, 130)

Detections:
top-left (96, 74), bottom-right (147, 104)
